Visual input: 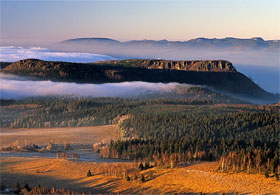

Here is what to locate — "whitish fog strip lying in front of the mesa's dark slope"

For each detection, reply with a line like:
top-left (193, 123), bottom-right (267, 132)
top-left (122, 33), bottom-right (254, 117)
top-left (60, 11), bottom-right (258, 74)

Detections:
top-left (0, 74), bottom-right (186, 98)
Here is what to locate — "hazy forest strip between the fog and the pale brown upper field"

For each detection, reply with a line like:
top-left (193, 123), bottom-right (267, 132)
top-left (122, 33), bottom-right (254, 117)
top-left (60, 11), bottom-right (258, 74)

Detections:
top-left (0, 97), bottom-right (232, 128)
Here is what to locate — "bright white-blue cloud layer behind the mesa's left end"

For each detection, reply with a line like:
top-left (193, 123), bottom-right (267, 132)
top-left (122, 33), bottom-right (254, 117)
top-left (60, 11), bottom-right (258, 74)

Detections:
top-left (0, 46), bottom-right (115, 63)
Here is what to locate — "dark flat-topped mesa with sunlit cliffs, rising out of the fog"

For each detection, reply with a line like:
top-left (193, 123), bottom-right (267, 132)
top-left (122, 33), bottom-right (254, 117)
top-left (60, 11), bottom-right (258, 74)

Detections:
top-left (2, 59), bottom-right (276, 101)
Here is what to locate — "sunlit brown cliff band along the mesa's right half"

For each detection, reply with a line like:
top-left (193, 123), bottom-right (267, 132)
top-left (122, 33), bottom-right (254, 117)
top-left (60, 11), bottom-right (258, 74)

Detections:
top-left (99, 60), bottom-right (236, 72)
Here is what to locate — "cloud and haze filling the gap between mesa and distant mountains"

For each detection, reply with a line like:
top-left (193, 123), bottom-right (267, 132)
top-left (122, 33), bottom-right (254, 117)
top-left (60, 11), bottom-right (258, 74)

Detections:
top-left (0, 42), bottom-right (280, 93)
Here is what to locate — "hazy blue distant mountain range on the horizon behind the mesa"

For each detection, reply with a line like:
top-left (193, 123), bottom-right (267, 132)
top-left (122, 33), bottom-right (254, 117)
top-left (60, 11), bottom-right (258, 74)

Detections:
top-left (53, 37), bottom-right (280, 67)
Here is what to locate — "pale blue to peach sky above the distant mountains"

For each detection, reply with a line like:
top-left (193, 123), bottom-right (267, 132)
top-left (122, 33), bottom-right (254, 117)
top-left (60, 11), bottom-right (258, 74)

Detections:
top-left (1, 0), bottom-right (280, 44)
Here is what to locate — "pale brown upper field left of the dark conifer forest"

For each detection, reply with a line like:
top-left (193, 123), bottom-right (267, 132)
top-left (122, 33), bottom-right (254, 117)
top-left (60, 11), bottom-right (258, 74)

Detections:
top-left (0, 125), bottom-right (118, 146)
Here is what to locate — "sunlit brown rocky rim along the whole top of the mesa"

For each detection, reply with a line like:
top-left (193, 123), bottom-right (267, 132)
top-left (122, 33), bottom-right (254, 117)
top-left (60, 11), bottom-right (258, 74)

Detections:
top-left (4, 59), bottom-right (236, 73)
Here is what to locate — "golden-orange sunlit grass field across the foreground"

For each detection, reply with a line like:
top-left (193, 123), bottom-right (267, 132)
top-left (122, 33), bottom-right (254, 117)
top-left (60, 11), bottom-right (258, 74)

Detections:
top-left (1, 158), bottom-right (280, 194)
